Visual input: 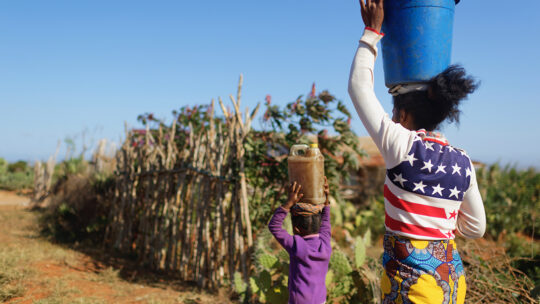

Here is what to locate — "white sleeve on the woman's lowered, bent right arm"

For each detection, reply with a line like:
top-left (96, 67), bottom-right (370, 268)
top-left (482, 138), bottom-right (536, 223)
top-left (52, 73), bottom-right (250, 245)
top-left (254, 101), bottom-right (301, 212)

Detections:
top-left (456, 162), bottom-right (486, 239)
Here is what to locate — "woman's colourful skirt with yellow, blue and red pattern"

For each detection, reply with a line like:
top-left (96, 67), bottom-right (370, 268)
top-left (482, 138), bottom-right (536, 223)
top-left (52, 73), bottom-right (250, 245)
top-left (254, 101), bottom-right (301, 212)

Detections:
top-left (381, 233), bottom-right (467, 304)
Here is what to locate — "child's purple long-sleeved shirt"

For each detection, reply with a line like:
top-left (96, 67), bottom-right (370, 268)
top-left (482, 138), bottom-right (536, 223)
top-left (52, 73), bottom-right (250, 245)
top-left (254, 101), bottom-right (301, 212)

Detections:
top-left (268, 206), bottom-right (332, 304)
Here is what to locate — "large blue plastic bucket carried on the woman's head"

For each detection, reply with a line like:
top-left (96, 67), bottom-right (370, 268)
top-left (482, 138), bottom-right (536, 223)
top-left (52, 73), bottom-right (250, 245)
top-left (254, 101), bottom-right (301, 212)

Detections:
top-left (381, 0), bottom-right (456, 88)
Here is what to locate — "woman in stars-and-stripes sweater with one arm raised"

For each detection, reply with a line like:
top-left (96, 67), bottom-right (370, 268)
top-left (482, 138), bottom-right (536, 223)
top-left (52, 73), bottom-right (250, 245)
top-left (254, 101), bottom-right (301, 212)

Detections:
top-left (349, 0), bottom-right (486, 303)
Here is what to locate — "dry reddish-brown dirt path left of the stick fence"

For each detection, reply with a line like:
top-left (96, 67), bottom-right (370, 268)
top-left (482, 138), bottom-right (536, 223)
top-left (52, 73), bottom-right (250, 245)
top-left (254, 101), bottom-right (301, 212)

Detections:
top-left (0, 191), bottom-right (230, 304)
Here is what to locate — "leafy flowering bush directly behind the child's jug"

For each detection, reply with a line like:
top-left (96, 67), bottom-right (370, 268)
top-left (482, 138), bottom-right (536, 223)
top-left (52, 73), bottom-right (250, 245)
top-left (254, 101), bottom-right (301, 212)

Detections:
top-left (245, 87), bottom-right (362, 228)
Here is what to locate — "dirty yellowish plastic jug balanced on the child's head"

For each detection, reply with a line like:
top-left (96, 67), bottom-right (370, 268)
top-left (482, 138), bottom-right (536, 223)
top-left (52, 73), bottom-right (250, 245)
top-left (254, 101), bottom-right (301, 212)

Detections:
top-left (287, 144), bottom-right (325, 205)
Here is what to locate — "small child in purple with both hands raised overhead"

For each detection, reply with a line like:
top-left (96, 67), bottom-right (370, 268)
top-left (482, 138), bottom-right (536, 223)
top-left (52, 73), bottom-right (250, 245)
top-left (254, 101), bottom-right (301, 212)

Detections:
top-left (268, 177), bottom-right (332, 304)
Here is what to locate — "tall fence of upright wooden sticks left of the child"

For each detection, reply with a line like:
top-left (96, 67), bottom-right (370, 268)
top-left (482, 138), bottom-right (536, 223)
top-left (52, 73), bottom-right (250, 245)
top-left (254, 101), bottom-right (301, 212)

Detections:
top-left (105, 77), bottom-right (259, 288)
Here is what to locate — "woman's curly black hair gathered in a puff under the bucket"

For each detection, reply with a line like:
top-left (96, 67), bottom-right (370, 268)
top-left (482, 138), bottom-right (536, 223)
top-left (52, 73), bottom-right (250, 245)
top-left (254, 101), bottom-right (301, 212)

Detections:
top-left (394, 65), bottom-right (480, 131)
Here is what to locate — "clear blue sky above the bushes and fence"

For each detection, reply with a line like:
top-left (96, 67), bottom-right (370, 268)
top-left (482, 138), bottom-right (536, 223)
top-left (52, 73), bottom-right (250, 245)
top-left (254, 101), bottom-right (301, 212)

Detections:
top-left (0, 0), bottom-right (540, 167)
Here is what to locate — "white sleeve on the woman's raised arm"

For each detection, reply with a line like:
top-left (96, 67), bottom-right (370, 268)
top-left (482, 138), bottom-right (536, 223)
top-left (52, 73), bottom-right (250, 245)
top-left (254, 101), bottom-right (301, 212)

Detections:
top-left (349, 30), bottom-right (416, 169)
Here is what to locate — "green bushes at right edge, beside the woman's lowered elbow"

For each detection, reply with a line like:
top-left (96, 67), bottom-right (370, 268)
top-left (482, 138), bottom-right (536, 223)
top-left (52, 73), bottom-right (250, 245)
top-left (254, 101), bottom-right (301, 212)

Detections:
top-left (476, 164), bottom-right (540, 296)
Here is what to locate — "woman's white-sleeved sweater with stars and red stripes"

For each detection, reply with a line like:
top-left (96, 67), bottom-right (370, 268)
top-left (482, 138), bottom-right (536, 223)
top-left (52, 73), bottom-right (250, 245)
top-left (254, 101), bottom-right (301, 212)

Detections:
top-left (349, 29), bottom-right (486, 240)
